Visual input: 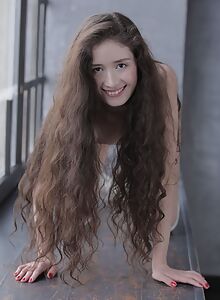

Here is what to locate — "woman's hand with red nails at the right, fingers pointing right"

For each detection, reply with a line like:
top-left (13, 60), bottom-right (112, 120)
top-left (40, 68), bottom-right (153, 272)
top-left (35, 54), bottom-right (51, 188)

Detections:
top-left (152, 265), bottom-right (209, 289)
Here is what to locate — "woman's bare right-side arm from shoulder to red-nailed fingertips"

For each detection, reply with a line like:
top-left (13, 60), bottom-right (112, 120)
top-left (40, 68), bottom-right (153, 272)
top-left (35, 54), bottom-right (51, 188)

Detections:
top-left (152, 65), bottom-right (208, 288)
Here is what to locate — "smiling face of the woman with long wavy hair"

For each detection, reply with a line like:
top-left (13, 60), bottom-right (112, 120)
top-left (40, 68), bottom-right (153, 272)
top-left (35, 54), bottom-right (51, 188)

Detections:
top-left (92, 40), bottom-right (137, 106)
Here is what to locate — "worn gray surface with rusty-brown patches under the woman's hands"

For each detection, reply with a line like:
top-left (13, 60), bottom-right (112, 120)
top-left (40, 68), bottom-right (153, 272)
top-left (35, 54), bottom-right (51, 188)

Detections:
top-left (0, 185), bottom-right (205, 300)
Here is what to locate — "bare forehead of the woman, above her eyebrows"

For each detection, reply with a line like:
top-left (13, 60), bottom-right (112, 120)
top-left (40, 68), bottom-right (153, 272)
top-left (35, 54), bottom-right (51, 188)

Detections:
top-left (92, 40), bottom-right (134, 64)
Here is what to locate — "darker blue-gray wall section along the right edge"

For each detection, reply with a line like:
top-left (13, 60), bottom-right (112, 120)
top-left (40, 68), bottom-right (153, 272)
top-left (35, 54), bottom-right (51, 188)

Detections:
top-left (182, 0), bottom-right (220, 276)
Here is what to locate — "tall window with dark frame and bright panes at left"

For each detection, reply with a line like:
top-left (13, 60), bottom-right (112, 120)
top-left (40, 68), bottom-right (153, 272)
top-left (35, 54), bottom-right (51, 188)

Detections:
top-left (0, 0), bottom-right (47, 202)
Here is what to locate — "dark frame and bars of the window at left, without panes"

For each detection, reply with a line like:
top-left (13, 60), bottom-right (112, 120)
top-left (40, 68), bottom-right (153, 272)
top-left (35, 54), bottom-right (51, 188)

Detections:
top-left (0, 0), bottom-right (48, 203)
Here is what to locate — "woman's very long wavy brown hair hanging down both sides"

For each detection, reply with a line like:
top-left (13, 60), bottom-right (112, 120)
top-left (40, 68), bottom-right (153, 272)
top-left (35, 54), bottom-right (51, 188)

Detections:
top-left (12, 13), bottom-right (180, 286)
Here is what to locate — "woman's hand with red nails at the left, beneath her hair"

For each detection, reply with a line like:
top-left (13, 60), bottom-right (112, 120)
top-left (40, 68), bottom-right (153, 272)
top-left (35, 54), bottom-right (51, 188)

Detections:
top-left (14, 257), bottom-right (57, 282)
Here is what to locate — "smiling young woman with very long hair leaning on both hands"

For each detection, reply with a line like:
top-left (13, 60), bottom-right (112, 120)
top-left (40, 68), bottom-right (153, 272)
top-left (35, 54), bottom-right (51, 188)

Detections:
top-left (14, 13), bottom-right (208, 288)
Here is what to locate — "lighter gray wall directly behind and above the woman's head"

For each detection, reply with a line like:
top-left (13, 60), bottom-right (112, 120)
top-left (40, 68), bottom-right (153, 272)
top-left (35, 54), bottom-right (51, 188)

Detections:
top-left (44, 0), bottom-right (186, 115)
